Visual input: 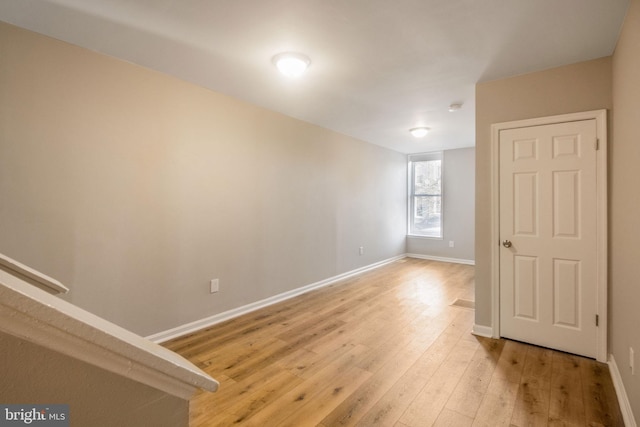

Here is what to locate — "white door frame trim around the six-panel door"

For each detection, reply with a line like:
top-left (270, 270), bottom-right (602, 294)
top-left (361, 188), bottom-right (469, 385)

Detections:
top-left (490, 110), bottom-right (608, 363)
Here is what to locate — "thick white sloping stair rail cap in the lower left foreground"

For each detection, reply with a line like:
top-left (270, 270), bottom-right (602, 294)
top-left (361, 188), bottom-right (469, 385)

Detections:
top-left (0, 260), bottom-right (218, 399)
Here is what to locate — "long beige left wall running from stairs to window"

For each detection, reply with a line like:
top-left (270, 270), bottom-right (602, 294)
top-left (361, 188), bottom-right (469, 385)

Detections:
top-left (0, 24), bottom-right (406, 335)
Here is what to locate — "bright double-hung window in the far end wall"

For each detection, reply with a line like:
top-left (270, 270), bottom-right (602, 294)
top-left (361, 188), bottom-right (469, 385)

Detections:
top-left (409, 152), bottom-right (442, 239)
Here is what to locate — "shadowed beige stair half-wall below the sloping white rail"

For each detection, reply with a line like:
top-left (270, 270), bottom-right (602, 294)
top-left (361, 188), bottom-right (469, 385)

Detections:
top-left (0, 333), bottom-right (189, 427)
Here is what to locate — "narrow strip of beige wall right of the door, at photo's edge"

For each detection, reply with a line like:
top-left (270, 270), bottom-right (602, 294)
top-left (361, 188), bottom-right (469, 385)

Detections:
top-left (609, 0), bottom-right (640, 422)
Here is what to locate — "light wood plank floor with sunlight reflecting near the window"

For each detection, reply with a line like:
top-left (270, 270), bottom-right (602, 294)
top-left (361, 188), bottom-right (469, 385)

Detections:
top-left (166, 258), bottom-right (623, 427)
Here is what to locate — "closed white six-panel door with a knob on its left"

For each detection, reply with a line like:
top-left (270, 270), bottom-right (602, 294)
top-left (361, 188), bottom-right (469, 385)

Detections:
top-left (499, 120), bottom-right (598, 357)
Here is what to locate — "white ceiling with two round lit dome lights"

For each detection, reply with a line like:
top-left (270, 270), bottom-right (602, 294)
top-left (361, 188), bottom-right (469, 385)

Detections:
top-left (0, 0), bottom-right (628, 153)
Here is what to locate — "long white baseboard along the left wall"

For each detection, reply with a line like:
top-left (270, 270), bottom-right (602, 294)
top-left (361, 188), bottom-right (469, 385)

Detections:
top-left (146, 255), bottom-right (406, 343)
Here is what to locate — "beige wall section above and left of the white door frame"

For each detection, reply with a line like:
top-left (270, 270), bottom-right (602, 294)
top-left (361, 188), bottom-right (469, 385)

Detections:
top-left (475, 57), bottom-right (612, 326)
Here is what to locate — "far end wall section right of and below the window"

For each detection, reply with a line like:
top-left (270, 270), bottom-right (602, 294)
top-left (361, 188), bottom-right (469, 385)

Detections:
top-left (407, 147), bottom-right (475, 261)
